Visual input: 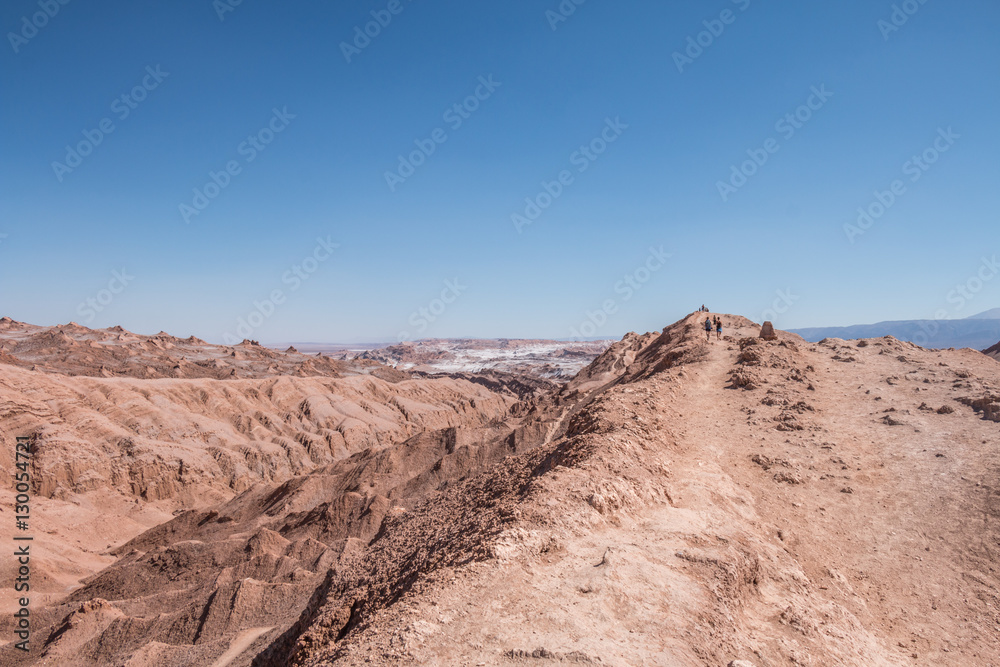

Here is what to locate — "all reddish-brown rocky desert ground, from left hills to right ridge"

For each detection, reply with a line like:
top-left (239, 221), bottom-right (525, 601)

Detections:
top-left (0, 313), bottom-right (1000, 667)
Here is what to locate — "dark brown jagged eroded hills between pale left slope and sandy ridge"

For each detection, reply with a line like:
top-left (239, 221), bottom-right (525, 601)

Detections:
top-left (0, 388), bottom-right (543, 665)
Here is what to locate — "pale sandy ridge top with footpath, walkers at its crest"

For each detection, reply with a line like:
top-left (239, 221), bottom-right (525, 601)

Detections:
top-left (318, 314), bottom-right (1000, 667)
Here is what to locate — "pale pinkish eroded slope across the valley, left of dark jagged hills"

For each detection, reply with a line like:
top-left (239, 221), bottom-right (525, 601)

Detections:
top-left (0, 358), bottom-right (516, 628)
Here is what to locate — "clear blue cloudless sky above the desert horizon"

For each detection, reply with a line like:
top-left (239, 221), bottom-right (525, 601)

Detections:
top-left (0, 0), bottom-right (1000, 342)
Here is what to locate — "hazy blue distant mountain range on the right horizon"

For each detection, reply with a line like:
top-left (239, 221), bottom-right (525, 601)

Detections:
top-left (789, 308), bottom-right (1000, 350)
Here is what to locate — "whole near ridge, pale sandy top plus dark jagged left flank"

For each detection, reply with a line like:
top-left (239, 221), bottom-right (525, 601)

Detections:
top-left (3, 314), bottom-right (1000, 667)
